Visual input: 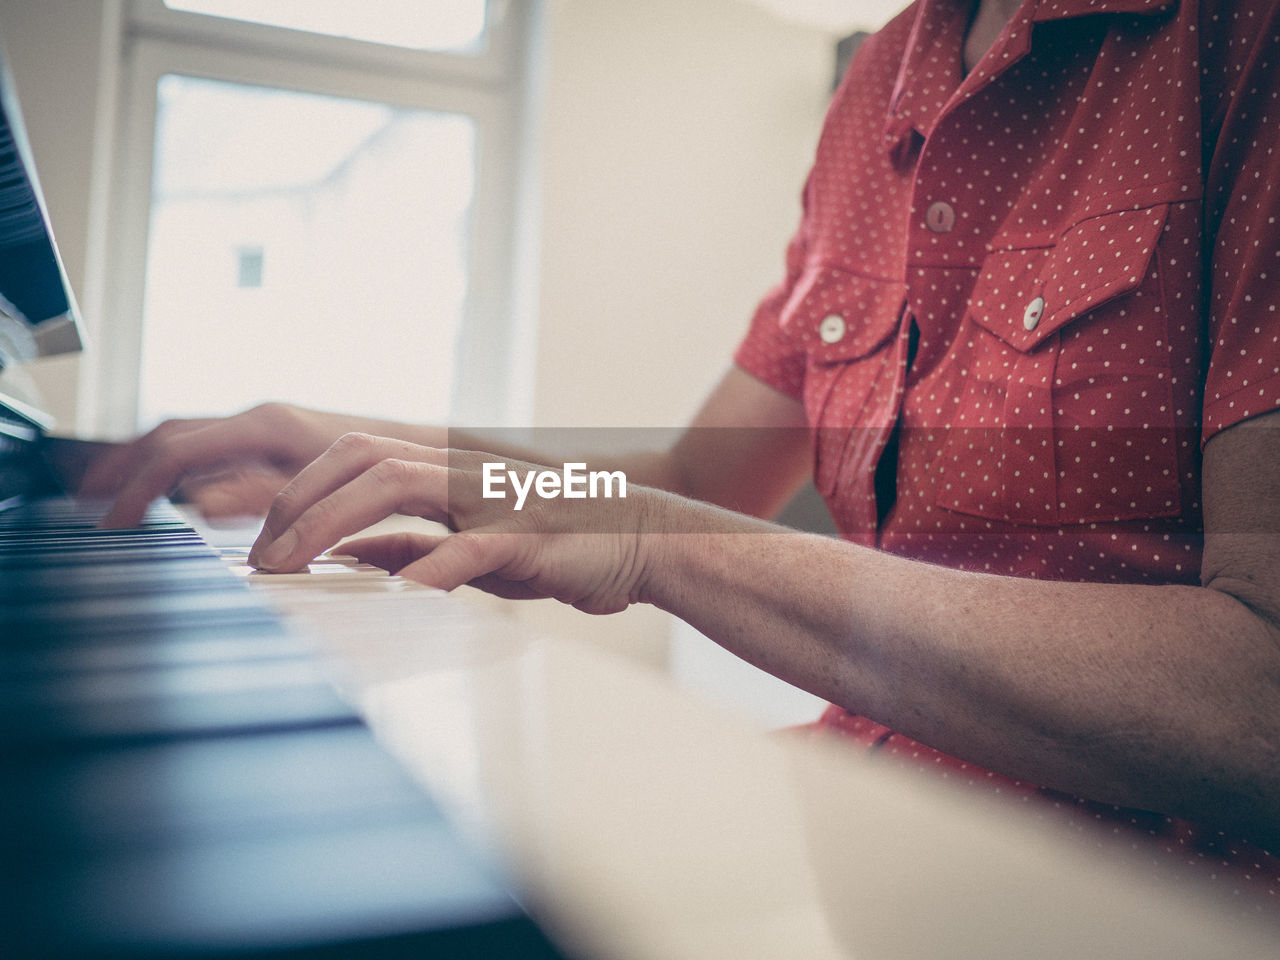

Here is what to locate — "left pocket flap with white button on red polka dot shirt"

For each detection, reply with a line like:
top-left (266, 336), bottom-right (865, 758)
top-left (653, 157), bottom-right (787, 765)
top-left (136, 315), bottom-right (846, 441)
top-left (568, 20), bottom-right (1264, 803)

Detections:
top-left (782, 266), bottom-right (906, 364)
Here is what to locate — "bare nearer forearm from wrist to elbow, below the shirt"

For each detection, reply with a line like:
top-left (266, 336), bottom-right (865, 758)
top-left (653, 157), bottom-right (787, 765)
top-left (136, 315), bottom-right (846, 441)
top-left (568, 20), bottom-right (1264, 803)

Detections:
top-left (644, 496), bottom-right (1280, 831)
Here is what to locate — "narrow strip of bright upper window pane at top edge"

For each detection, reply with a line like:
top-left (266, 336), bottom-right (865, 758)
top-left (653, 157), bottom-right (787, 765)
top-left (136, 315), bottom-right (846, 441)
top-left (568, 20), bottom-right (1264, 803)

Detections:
top-left (157, 0), bottom-right (485, 50)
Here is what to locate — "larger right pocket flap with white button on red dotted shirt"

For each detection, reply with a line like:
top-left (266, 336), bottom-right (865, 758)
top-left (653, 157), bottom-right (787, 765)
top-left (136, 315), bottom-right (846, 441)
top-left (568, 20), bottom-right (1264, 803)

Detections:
top-left (970, 204), bottom-right (1169, 352)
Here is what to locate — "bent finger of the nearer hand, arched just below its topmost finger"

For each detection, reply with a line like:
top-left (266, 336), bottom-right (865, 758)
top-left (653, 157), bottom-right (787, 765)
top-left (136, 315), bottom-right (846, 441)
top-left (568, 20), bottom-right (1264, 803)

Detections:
top-left (248, 460), bottom-right (448, 573)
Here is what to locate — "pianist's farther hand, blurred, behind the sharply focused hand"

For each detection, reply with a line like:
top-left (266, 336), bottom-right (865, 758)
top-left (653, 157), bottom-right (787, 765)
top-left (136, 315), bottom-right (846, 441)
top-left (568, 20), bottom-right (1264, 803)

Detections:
top-left (79, 403), bottom-right (440, 527)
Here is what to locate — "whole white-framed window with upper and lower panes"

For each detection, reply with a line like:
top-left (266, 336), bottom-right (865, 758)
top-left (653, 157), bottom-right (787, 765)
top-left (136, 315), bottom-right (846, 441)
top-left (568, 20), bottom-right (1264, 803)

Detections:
top-left (100, 0), bottom-right (529, 431)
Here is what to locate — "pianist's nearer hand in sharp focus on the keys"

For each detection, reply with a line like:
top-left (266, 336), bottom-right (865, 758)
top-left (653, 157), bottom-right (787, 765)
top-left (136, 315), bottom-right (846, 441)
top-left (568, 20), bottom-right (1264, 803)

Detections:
top-left (250, 434), bottom-right (660, 613)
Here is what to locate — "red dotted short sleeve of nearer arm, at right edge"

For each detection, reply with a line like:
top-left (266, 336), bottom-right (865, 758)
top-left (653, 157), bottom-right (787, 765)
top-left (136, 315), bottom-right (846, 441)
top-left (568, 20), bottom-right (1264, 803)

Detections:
top-left (1202, 3), bottom-right (1280, 442)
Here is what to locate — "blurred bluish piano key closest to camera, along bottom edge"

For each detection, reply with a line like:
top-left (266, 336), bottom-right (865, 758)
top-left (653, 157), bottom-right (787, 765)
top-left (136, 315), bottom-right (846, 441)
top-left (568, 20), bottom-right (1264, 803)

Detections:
top-left (5, 812), bottom-right (554, 960)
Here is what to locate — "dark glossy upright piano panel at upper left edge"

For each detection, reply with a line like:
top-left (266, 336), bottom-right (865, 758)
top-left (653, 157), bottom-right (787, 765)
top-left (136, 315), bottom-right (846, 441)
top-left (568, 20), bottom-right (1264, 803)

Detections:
top-left (0, 34), bottom-right (83, 369)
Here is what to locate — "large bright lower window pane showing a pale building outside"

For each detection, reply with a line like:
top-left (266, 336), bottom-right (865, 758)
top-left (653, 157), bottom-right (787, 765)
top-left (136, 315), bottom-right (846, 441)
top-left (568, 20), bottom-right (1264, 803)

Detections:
top-left (140, 76), bottom-right (476, 424)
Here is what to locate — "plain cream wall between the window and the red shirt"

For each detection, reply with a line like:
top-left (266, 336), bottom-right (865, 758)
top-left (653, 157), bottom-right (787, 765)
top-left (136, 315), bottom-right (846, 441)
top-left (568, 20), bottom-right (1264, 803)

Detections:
top-left (535, 0), bottom-right (833, 426)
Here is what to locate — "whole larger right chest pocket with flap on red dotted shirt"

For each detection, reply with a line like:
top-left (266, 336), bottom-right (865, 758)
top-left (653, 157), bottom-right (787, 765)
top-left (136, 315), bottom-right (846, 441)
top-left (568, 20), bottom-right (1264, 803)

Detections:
top-left (937, 205), bottom-right (1183, 525)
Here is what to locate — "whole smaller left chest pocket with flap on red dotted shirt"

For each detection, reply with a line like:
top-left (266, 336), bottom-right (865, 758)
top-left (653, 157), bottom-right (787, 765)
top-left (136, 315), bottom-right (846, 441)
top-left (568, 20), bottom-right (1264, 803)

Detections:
top-left (782, 264), bottom-right (906, 497)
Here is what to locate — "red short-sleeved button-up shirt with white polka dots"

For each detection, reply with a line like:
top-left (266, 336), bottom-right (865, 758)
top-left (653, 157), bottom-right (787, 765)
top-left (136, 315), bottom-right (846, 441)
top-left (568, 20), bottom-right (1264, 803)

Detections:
top-left (735, 0), bottom-right (1280, 902)
